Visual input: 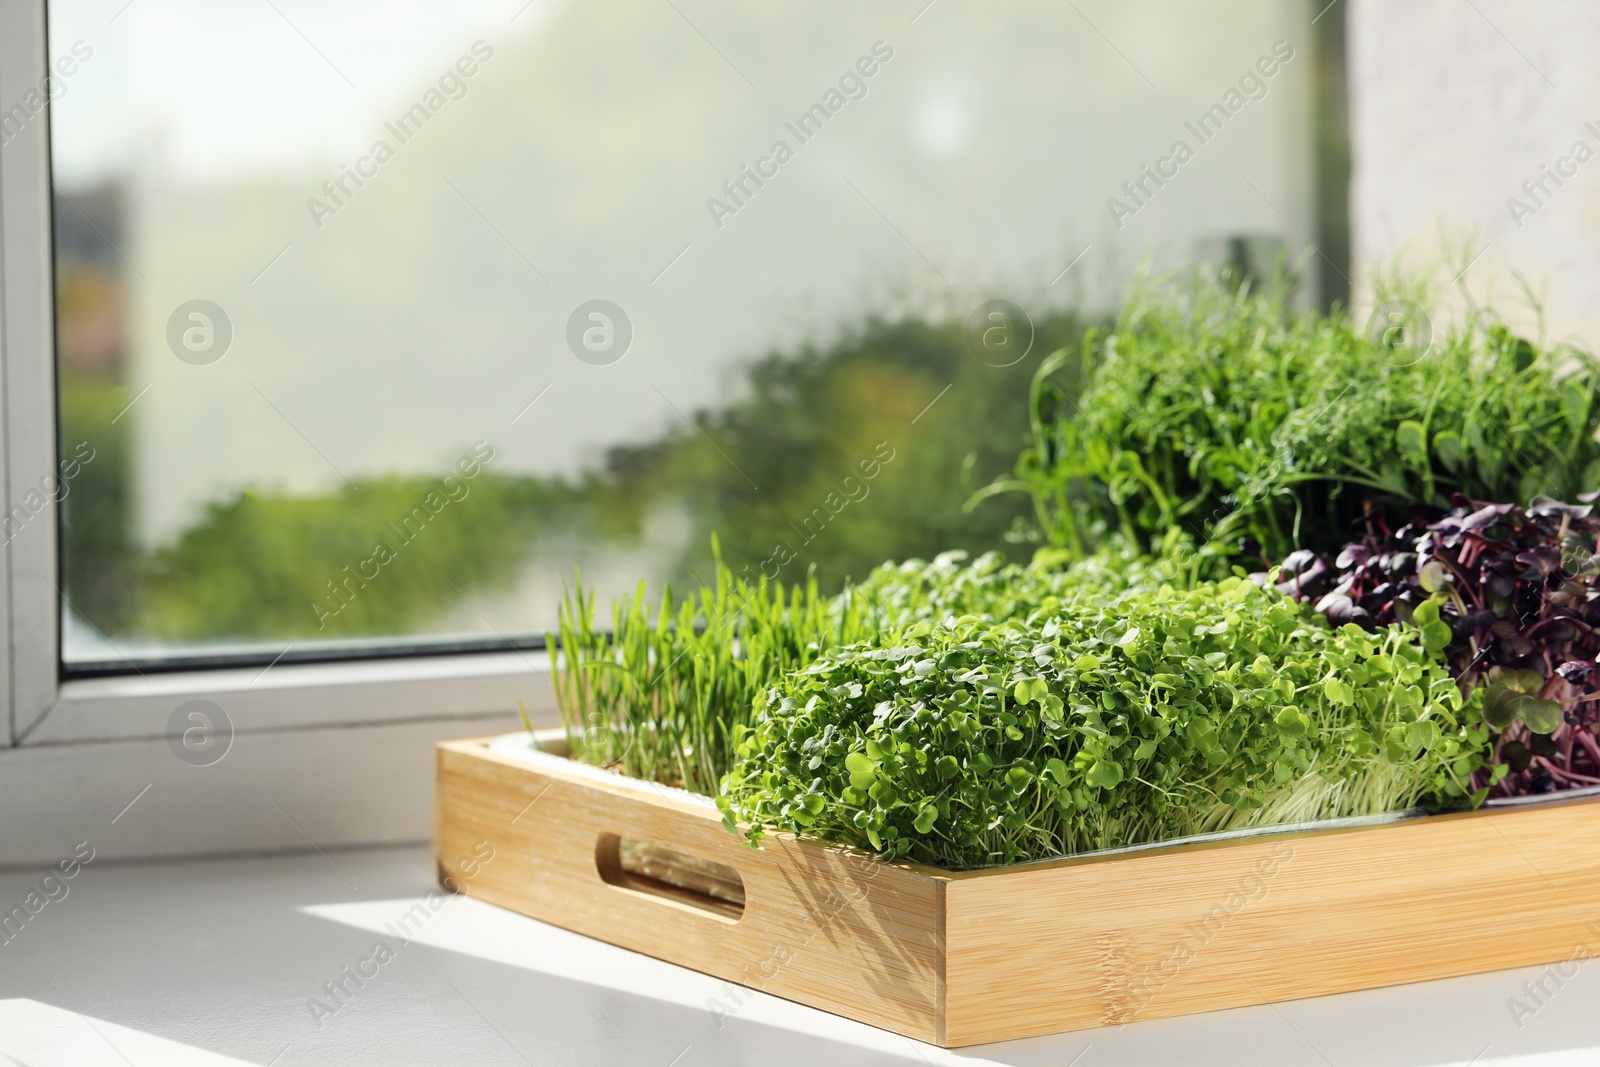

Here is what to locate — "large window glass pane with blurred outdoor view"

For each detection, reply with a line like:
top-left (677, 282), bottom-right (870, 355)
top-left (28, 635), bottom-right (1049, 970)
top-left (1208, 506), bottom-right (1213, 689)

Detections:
top-left (50, 0), bottom-right (1338, 669)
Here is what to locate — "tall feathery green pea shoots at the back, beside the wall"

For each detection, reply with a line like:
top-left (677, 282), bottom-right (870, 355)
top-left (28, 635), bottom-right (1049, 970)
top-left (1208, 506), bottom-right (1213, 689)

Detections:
top-left (973, 278), bottom-right (1600, 571)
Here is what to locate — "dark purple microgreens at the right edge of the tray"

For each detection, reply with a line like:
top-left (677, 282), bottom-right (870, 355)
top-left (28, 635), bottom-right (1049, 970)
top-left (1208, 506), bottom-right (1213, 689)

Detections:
top-left (1278, 498), bottom-right (1600, 797)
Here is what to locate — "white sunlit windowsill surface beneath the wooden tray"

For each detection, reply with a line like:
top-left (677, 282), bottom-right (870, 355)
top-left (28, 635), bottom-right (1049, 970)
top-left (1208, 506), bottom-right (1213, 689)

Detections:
top-left (0, 844), bottom-right (1600, 1067)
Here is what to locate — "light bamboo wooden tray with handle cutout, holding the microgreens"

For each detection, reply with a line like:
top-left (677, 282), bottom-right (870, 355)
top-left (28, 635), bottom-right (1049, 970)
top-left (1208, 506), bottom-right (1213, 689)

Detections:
top-left (435, 739), bottom-right (1600, 1046)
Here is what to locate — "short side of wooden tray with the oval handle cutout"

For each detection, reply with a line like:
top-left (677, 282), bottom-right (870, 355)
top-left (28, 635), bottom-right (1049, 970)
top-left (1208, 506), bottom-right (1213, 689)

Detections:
top-left (435, 741), bottom-right (944, 1043)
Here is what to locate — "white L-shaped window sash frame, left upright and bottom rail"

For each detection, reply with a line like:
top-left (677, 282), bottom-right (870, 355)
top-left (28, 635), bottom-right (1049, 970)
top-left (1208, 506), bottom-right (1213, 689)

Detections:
top-left (0, 0), bottom-right (554, 844)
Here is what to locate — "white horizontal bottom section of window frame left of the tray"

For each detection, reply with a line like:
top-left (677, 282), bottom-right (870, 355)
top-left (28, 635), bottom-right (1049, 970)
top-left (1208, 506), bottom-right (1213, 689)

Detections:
top-left (0, 653), bottom-right (557, 870)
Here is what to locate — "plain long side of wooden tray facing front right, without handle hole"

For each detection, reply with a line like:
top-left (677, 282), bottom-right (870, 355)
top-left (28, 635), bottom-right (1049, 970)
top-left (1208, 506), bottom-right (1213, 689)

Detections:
top-left (946, 801), bottom-right (1600, 1045)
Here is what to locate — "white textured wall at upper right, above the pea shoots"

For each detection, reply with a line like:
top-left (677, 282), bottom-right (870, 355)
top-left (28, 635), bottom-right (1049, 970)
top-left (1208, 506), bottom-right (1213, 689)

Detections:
top-left (1349, 0), bottom-right (1600, 350)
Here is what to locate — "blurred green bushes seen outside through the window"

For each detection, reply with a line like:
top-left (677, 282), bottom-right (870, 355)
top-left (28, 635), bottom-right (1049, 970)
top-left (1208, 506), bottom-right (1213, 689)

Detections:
top-left (61, 314), bottom-right (1083, 641)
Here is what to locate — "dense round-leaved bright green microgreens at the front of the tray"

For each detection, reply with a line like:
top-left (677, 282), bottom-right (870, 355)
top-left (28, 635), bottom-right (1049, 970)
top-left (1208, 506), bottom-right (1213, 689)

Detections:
top-left (718, 577), bottom-right (1485, 869)
